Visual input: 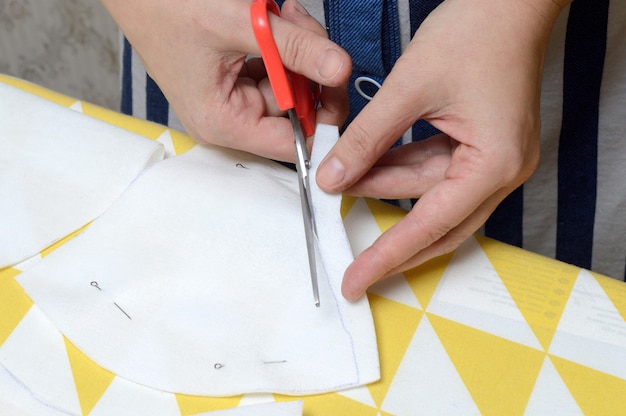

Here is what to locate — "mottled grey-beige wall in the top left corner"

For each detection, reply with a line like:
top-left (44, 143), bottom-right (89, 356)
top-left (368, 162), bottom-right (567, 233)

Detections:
top-left (0, 0), bottom-right (120, 110)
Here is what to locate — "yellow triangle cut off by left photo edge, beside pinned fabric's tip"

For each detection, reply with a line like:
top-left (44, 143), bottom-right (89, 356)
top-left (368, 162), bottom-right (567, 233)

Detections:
top-left (0, 267), bottom-right (33, 345)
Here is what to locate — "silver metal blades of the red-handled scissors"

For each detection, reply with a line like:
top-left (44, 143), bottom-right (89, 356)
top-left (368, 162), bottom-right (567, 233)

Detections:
top-left (287, 109), bottom-right (320, 307)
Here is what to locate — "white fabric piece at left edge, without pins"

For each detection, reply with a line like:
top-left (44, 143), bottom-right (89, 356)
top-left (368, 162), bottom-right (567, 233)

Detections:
top-left (0, 84), bottom-right (163, 268)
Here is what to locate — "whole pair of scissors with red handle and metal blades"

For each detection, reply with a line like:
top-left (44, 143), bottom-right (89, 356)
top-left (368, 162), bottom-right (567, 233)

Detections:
top-left (250, 0), bottom-right (320, 307)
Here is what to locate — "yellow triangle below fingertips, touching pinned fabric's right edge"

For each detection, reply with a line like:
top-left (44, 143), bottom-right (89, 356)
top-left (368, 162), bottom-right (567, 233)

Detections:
top-left (368, 294), bottom-right (424, 407)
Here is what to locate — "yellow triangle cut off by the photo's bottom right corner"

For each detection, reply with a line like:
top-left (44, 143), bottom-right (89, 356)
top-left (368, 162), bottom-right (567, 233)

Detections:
top-left (549, 355), bottom-right (626, 415)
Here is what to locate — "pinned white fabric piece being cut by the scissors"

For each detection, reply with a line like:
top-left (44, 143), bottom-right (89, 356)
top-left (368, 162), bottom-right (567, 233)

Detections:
top-left (18, 126), bottom-right (379, 396)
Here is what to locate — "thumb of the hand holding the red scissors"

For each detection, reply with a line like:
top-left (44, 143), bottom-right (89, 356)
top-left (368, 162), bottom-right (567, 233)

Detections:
top-left (269, 0), bottom-right (352, 87)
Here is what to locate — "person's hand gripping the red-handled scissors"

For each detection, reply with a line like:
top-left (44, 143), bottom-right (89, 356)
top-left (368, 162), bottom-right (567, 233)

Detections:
top-left (101, 0), bottom-right (352, 161)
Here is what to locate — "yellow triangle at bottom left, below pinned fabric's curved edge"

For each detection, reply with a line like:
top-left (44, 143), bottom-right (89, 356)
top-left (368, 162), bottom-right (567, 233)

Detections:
top-left (63, 337), bottom-right (115, 415)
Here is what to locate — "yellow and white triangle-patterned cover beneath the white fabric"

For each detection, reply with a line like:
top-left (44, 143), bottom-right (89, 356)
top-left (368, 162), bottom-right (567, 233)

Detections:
top-left (0, 76), bottom-right (626, 416)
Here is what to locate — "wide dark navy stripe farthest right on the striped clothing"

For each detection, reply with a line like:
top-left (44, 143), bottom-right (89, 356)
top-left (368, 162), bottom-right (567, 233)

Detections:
top-left (556, 0), bottom-right (609, 268)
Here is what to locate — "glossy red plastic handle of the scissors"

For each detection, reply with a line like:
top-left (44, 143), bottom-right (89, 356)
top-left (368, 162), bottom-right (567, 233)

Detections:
top-left (250, 0), bottom-right (317, 137)
